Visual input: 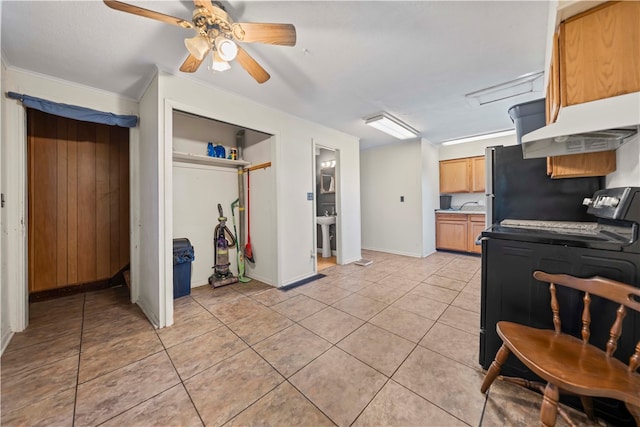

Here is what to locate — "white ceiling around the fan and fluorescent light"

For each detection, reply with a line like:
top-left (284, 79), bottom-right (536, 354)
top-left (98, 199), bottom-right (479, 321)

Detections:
top-left (1, 0), bottom-right (549, 149)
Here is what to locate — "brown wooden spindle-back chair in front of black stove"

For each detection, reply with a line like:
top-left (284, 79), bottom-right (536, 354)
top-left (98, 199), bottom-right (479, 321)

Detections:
top-left (480, 271), bottom-right (640, 426)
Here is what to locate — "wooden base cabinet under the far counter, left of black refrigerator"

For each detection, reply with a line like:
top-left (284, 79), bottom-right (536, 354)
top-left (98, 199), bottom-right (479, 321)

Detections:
top-left (436, 213), bottom-right (484, 254)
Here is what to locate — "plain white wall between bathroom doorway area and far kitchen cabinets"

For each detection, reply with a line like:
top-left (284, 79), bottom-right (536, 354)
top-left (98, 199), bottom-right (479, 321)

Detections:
top-left (362, 139), bottom-right (428, 257)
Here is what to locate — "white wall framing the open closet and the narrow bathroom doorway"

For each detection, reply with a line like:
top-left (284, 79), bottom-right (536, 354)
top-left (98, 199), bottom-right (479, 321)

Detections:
top-left (158, 73), bottom-right (360, 310)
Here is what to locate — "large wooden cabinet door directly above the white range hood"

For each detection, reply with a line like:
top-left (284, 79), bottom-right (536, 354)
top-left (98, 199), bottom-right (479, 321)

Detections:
top-left (560, 1), bottom-right (640, 106)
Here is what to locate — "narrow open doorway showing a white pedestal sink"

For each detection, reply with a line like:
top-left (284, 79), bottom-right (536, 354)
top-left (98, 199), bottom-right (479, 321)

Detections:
top-left (315, 145), bottom-right (339, 271)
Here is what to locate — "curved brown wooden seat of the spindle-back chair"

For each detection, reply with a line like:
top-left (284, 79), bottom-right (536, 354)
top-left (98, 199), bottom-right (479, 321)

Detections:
top-left (496, 321), bottom-right (640, 405)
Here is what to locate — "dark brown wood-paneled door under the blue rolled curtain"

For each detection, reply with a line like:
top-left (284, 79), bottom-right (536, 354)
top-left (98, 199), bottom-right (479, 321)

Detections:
top-left (27, 109), bottom-right (129, 293)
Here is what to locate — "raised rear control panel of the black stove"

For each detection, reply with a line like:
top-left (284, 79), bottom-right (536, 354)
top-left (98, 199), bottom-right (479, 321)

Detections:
top-left (582, 187), bottom-right (640, 221)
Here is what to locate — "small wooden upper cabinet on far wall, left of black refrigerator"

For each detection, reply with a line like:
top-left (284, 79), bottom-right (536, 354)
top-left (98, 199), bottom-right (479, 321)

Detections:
top-left (440, 156), bottom-right (484, 194)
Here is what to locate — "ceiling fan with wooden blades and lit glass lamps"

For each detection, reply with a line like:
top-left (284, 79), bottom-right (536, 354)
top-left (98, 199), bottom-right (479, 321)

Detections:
top-left (104, 0), bottom-right (296, 83)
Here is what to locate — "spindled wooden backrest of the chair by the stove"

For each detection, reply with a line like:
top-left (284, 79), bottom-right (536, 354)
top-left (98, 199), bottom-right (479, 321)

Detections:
top-left (533, 271), bottom-right (640, 372)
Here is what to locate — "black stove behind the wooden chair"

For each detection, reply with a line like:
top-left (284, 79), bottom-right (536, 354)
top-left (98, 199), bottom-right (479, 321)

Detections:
top-left (479, 187), bottom-right (640, 426)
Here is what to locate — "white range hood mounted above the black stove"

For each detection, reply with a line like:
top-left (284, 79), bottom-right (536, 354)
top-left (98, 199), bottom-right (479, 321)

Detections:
top-left (522, 92), bottom-right (640, 159)
